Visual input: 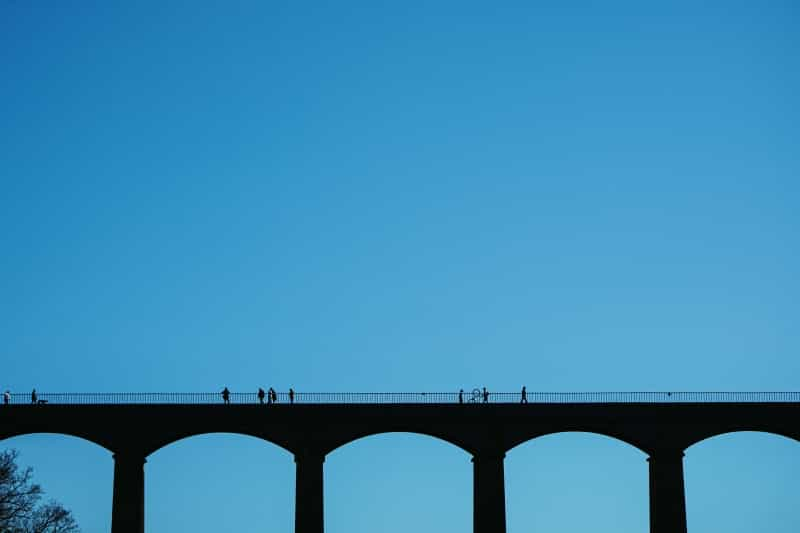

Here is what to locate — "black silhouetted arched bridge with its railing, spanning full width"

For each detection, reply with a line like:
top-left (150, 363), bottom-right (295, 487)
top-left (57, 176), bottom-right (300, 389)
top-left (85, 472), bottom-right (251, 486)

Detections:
top-left (0, 389), bottom-right (800, 533)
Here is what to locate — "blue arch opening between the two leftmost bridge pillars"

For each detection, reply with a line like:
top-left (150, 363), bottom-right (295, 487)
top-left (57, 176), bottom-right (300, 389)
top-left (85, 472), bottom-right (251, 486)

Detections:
top-left (145, 432), bottom-right (295, 533)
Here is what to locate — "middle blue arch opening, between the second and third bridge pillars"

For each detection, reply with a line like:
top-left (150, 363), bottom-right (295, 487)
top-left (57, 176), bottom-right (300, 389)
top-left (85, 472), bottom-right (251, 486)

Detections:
top-left (325, 432), bottom-right (472, 533)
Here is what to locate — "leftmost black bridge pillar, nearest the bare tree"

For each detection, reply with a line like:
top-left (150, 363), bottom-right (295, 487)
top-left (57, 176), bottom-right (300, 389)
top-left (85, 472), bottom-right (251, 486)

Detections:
top-left (111, 452), bottom-right (146, 533)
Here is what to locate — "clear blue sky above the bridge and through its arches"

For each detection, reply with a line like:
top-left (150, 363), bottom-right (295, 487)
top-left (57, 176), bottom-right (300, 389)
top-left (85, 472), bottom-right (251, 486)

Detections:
top-left (0, 1), bottom-right (800, 533)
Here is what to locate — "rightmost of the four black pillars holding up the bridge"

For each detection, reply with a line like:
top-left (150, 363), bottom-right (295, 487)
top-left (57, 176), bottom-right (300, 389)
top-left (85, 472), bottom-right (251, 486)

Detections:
top-left (647, 450), bottom-right (686, 533)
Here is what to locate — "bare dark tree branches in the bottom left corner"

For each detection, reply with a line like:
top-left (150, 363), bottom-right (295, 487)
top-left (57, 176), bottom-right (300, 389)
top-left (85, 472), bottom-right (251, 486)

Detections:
top-left (0, 450), bottom-right (80, 533)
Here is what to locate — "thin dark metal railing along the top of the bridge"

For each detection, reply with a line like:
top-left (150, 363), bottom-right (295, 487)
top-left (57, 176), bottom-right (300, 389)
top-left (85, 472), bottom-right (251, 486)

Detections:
top-left (1, 389), bottom-right (800, 405)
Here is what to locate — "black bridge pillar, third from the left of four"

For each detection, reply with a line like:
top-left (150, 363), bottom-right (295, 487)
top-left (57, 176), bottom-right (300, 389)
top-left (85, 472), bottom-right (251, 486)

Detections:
top-left (472, 451), bottom-right (506, 533)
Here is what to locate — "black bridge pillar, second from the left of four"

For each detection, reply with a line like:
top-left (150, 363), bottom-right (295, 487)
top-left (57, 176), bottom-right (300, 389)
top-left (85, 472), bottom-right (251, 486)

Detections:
top-left (294, 452), bottom-right (325, 533)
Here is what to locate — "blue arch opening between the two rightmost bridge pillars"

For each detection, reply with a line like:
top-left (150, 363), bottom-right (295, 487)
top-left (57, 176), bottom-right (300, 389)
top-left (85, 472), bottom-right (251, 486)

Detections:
top-left (505, 431), bottom-right (649, 533)
